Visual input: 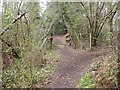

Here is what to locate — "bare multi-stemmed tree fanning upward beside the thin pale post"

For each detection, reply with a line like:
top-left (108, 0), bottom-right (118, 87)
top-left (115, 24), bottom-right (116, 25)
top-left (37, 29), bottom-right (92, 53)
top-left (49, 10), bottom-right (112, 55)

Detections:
top-left (80, 2), bottom-right (117, 46)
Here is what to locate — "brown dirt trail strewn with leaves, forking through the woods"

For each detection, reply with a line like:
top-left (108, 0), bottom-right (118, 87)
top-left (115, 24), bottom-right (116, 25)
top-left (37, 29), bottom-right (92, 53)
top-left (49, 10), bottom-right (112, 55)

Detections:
top-left (48, 36), bottom-right (110, 88)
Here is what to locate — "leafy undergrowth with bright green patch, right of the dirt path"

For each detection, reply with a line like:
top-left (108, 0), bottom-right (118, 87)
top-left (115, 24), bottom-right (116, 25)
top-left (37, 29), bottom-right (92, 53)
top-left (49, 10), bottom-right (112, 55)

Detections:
top-left (78, 53), bottom-right (117, 88)
